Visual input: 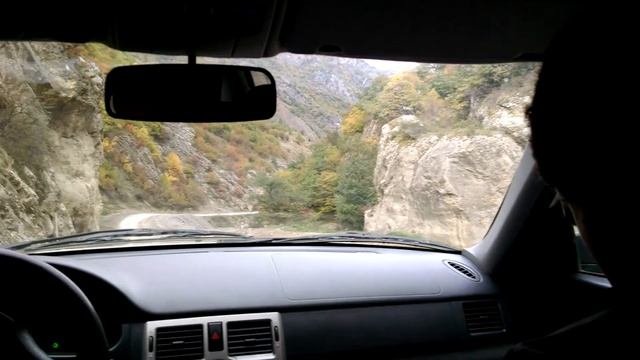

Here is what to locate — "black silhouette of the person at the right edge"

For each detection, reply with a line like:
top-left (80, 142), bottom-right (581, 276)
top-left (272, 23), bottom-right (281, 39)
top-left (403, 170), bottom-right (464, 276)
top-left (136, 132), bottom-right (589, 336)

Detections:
top-left (506, 10), bottom-right (640, 360)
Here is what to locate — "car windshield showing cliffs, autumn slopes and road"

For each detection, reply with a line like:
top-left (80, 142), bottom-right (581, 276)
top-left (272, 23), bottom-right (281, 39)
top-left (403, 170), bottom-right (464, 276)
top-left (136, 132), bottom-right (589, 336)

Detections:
top-left (0, 42), bottom-right (538, 249)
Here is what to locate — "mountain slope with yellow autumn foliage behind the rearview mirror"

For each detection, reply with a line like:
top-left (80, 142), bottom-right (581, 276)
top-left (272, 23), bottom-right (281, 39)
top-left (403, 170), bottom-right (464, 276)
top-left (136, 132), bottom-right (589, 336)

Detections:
top-left (76, 44), bottom-right (377, 212)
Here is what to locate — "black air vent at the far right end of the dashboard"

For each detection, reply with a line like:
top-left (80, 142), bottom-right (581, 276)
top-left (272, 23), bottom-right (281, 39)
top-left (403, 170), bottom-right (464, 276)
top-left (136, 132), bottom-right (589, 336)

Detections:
top-left (462, 300), bottom-right (505, 335)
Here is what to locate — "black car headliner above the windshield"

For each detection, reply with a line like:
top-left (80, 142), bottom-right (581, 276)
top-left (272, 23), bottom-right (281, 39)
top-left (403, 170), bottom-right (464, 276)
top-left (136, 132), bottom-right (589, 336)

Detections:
top-left (0, 0), bottom-right (573, 63)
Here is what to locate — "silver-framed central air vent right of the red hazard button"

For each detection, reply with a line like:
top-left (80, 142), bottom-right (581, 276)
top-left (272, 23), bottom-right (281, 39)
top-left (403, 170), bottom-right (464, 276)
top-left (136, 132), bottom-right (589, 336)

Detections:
top-left (227, 320), bottom-right (273, 356)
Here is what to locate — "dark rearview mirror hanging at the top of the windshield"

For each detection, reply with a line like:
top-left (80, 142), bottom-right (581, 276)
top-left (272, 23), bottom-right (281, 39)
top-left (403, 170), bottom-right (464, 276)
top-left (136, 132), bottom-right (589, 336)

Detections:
top-left (105, 64), bottom-right (276, 122)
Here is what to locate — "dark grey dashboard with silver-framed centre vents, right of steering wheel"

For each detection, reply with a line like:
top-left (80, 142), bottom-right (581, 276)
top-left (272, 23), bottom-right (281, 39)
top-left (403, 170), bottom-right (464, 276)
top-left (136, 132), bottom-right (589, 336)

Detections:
top-left (36, 246), bottom-right (509, 359)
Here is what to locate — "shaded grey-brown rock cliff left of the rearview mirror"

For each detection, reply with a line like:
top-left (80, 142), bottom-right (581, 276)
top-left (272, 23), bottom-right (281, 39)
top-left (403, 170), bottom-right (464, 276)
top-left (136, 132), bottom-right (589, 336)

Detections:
top-left (0, 43), bottom-right (102, 243)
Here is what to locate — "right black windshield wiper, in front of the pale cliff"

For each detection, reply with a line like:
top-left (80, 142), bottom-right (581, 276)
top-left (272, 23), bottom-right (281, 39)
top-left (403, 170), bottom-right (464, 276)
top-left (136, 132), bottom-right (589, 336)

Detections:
top-left (242, 231), bottom-right (459, 252)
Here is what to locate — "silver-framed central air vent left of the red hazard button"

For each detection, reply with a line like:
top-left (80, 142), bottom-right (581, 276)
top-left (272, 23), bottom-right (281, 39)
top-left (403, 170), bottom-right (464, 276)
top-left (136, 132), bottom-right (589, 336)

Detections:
top-left (156, 324), bottom-right (204, 360)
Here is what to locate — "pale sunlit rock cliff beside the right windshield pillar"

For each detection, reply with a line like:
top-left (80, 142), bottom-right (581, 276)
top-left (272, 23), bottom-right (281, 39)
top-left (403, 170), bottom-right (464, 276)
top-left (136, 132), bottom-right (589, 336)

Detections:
top-left (365, 80), bottom-right (534, 248)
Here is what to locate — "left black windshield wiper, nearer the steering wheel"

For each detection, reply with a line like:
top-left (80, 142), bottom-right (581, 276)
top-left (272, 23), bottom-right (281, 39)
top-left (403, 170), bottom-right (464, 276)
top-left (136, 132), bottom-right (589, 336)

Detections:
top-left (8, 229), bottom-right (250, 250)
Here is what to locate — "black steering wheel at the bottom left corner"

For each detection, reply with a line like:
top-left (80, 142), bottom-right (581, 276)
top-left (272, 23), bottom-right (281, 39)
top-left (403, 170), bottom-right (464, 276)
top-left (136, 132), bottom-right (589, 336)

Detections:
top-left (0, 249), bottom-right (109, 360)
